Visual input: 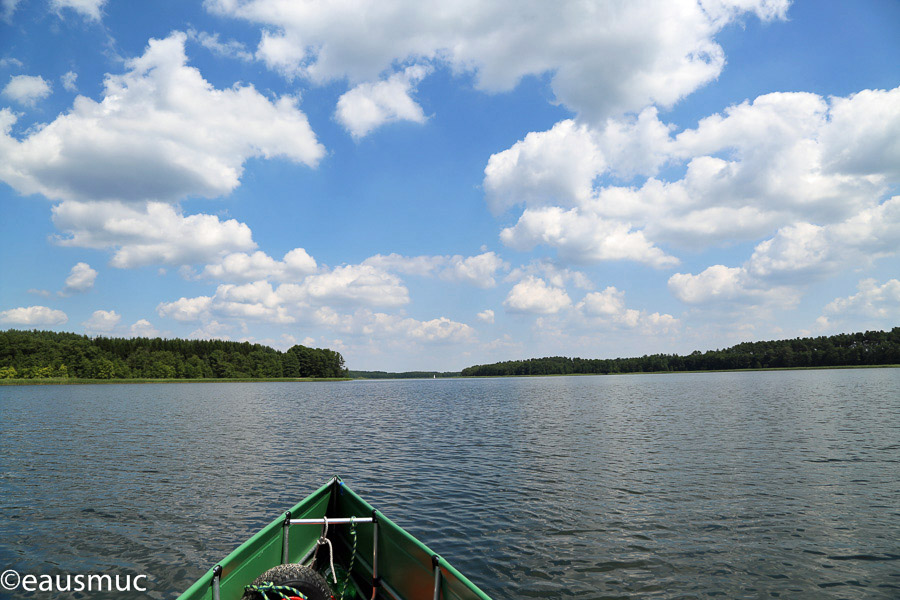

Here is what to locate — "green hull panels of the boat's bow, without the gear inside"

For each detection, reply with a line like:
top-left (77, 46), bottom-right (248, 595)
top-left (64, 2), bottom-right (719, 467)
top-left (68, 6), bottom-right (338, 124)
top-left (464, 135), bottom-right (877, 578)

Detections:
top-left (178, 477), bottom-right (490, 600)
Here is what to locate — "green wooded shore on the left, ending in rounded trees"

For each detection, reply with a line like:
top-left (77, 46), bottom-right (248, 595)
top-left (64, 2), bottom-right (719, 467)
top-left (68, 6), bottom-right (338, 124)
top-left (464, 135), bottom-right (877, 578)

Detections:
top-left (0, 329), bottom-right (347, 379)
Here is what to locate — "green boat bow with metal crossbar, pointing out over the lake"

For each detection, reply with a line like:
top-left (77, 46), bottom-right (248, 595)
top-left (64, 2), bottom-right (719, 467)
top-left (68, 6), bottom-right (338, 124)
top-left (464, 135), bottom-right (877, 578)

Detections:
top-left (178, 477), bottom-right (490, 600)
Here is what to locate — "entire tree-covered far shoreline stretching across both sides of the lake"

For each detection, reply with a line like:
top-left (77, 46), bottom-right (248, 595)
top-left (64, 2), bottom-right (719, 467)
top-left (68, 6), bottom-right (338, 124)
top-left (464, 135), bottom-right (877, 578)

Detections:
top-left (7, 327), bottom-right (900, 379)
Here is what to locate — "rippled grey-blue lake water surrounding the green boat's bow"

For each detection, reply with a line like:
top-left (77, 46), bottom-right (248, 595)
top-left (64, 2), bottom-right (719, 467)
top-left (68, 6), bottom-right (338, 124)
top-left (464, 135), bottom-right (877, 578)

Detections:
top-left (0, 369), bottom-right (900, 600)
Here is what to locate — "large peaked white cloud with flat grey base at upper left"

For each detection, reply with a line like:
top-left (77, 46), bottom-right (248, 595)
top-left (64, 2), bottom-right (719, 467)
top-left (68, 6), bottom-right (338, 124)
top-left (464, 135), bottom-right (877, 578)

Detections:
top-left (0, 32), bottom-right (324, 206)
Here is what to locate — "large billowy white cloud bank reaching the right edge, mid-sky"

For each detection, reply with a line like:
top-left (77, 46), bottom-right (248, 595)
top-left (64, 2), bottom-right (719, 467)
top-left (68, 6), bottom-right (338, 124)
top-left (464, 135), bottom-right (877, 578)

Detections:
top-left (483, 88), bottom-right (900, 276)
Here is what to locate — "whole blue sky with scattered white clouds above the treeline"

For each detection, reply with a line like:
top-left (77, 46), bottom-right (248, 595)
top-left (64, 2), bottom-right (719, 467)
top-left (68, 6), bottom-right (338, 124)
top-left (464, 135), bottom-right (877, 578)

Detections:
top-left (0, 0), bottom-right (900, 370)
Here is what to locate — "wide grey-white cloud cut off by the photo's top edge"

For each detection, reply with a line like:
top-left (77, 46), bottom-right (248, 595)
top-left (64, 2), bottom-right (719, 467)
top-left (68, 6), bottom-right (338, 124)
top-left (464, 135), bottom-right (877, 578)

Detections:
top-left (206, 0), bottom-right (788, 118)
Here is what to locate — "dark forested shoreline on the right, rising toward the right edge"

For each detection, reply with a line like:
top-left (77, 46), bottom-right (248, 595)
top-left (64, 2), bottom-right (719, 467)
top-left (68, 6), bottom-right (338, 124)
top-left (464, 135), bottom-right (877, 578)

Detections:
top-left (462, 327), bottom-right (900, 377)
